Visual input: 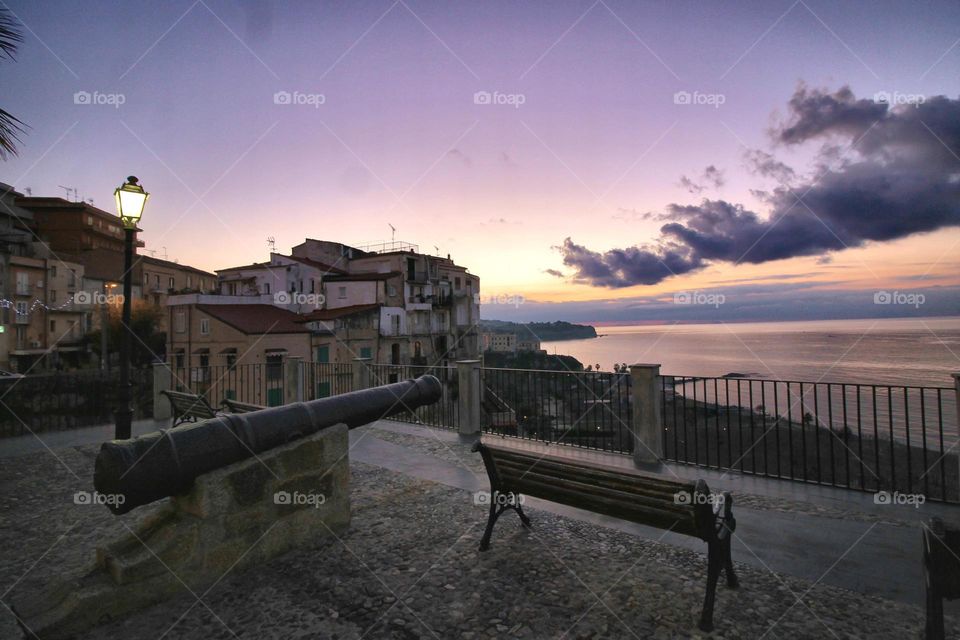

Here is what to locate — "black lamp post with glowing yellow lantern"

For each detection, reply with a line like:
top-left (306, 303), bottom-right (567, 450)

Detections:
top-left (113, 176), bottom-right (150, 440)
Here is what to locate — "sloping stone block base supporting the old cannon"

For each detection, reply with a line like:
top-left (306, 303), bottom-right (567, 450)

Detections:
top-left (13, 424), bottom-right (350, 640)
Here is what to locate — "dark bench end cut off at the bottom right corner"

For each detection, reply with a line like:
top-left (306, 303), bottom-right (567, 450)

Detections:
top-left (923, 518), bottom-right (960, 640)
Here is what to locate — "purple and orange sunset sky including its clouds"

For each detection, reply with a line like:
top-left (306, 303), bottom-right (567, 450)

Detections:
top-left (0, 0), bottom-right (960, 321)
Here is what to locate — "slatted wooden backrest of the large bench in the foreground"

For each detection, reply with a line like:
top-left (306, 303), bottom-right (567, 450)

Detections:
top-left (476, 443), bottom-right (716, 540)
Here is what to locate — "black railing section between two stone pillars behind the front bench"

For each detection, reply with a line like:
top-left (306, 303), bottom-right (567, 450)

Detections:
top-left (481, 368), bottom-right (633, 453)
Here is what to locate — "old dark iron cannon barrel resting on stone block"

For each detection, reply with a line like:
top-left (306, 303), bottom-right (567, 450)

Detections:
top-left (93, 375), bottom-right (442, 514)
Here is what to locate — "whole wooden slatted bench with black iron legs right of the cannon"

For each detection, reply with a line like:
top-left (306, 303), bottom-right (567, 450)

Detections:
top-left (473, 442), bottom-right (739, 631)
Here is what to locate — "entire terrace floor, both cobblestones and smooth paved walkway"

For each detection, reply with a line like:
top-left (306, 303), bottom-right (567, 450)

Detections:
top-left (0, 421), bottom-right (960, 640)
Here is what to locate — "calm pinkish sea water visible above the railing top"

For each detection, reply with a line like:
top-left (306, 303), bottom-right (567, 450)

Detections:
top-left (542, 316), bottom-right (960, 387)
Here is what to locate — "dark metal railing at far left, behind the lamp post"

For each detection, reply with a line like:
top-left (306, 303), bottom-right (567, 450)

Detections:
top-left (0, 369), bottom-right (153, 437)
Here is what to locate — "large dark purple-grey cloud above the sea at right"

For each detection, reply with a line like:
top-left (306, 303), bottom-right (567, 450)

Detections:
top-left (560, 86), bottom-right (960, 288)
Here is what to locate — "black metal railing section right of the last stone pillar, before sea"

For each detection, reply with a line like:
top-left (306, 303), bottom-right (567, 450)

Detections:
top-left (661, 376), bottom-right (960, 502)
